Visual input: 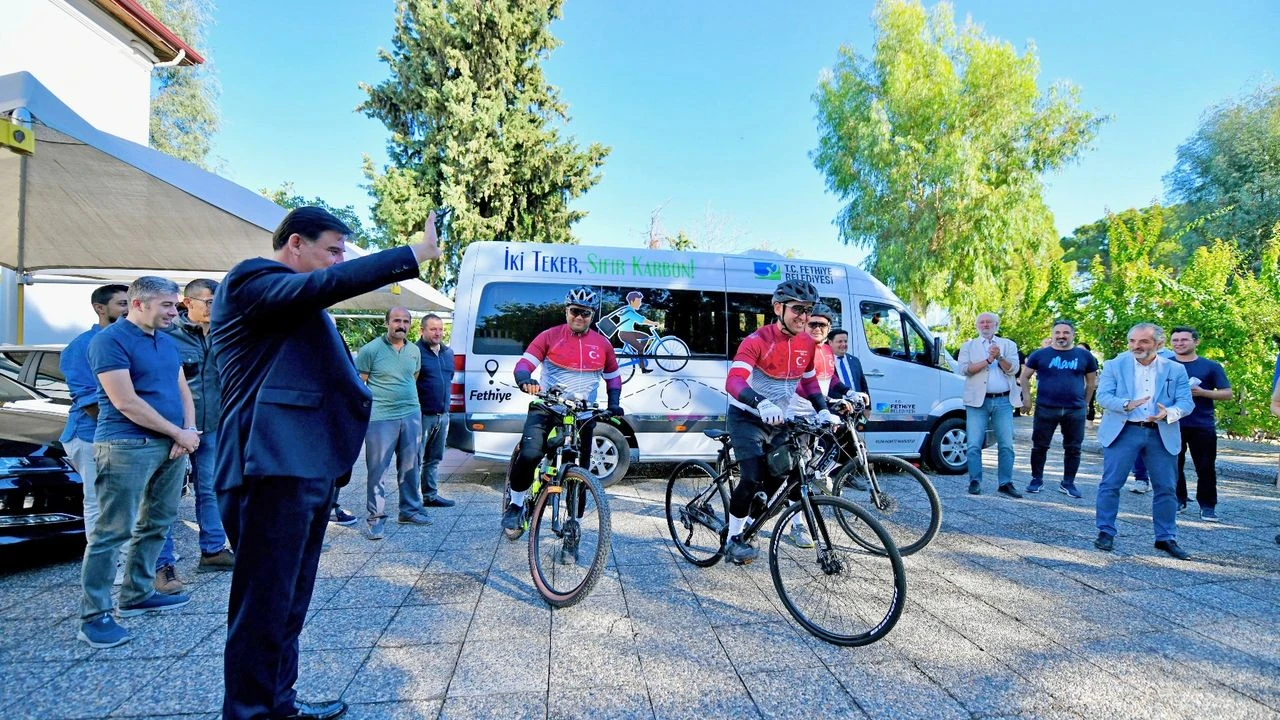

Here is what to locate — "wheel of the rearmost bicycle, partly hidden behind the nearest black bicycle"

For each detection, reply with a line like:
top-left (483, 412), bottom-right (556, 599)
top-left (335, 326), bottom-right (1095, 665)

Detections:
top-left (832, 455), bottom-right (942, 556)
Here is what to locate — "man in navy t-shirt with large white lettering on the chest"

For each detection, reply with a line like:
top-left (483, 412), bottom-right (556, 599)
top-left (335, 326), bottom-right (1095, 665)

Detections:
top-left (1018, 320), bottom-right (1098, 498)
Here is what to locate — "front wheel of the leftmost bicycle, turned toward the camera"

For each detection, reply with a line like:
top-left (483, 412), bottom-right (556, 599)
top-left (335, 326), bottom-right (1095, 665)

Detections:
top-left (529, 468), bottom-right (612, 607)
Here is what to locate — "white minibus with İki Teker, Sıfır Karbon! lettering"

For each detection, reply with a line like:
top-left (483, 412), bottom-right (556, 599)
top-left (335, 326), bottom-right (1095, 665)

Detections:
top-left (449, 242), bottom-right (965, 483)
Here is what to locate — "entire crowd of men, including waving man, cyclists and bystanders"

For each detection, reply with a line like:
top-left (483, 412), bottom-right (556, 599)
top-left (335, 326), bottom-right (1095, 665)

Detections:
top-left (61, 208), bottom-right (1280, 719)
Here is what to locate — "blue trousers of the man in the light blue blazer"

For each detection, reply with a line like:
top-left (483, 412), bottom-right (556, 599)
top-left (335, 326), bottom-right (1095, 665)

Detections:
top-left (1097, 423), bottom-right (1178, 542)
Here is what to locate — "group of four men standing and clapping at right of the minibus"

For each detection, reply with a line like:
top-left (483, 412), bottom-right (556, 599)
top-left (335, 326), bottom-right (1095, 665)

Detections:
top-left (959, 313), bottom-right (1249, 560)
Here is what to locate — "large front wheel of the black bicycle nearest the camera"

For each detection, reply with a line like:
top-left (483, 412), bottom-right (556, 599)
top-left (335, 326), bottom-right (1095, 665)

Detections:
top-left (769, 496), bottom-right (906, 646)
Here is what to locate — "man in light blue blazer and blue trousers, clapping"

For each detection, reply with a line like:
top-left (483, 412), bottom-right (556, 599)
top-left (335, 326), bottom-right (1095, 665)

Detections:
top-left (1093, 323), bottom-right (1196, 560)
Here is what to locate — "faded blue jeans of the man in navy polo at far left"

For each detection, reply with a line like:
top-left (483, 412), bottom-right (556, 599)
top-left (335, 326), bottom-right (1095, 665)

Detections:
top-left (81, 438), bottom-right (186, 623)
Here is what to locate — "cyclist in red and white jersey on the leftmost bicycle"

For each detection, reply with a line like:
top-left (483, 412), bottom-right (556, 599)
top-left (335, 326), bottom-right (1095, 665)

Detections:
top-left (502, 286), bottom-right (622, 530)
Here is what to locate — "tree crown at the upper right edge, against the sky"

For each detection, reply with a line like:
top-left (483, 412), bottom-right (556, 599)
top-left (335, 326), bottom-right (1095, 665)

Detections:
top-left (1165, 85), bottom-right (1280, 270)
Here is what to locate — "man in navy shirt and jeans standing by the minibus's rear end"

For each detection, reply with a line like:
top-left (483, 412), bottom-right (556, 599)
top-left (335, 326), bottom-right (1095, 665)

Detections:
top-left (417, 315), bottom-right (454, 507)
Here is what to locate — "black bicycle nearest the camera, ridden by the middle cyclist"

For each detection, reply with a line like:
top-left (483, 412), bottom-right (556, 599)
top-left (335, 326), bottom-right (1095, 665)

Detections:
top-left (666, 418), bottom-right (906, 646)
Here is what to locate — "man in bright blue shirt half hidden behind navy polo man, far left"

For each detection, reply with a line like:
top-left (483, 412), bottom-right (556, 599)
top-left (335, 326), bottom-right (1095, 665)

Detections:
top-left (58, 284), bottom-right (129, 538)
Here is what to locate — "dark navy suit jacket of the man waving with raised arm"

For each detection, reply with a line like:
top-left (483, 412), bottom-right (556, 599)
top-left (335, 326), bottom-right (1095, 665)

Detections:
top-left (210, 247), bottom-right (417, 489)
